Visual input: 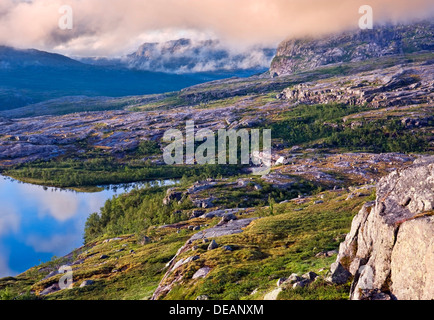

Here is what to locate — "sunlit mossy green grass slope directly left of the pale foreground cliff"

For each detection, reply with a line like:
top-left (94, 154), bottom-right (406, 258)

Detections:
top-left (165, 192), bottom-right (372, 300)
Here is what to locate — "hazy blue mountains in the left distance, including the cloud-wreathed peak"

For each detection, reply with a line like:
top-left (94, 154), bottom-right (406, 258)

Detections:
top-left (0, 39), bottom-right (274, 111)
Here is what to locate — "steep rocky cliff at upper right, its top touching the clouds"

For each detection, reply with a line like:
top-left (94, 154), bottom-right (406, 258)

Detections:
top-left (270, 22), bottom-right (434, 76)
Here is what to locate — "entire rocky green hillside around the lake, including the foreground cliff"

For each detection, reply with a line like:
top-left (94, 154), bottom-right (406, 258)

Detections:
top-left (0, 24), bottom-right (434, 300)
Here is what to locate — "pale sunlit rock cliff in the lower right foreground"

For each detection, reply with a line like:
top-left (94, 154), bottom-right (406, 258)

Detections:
top-left (329, 156), bottom-right (434, 300)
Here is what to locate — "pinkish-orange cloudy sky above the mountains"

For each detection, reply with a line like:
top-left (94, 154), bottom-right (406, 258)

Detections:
top-left (0, 0), bottom-right (434, 57)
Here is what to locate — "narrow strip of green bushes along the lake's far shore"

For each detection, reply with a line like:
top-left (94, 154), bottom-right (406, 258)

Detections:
top-left (2, 159), bottom-right (241, 188)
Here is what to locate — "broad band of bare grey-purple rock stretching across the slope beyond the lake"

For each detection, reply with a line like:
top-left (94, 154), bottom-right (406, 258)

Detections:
top-left (0, 61), bottom-right (434, 166)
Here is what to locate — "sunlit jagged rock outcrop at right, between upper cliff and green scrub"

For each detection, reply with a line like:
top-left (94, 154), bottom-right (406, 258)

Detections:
top-left (278, 61), bottom-right (434, 108)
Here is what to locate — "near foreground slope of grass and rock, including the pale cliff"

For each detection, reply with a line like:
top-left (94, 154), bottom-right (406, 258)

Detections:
top-left (0, 157), bottom-right (433, 300)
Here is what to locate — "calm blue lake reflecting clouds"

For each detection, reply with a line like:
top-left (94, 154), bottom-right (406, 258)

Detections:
top-left (0, 176), bottom-right (176, 278)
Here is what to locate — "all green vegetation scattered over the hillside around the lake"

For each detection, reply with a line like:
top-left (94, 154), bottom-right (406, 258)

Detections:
top-left (0, 48), bottom-right (434, 300)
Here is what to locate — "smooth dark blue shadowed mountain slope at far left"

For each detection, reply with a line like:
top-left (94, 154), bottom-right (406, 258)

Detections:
top-left (0, 47), bottom-right (262, 115)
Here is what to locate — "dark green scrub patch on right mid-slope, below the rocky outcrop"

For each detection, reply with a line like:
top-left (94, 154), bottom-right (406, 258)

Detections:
top-left (271, 104), bottom-right (434, 152)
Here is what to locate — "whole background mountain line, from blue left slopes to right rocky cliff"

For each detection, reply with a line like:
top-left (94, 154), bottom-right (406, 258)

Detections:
top-left (0, 21), bottom-right (434, 115)
